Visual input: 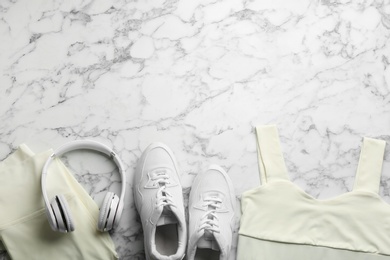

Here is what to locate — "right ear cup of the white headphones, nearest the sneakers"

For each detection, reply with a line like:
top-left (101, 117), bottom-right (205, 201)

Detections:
top-left (98, 192), bottom-right (119, 231)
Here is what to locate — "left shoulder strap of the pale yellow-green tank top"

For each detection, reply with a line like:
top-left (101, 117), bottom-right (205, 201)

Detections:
top-left (256, 125), bottom-right (288, 184)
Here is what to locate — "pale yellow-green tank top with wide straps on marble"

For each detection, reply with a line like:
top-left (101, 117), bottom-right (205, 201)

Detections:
top-left (237, 126), bottom-right (390, 260)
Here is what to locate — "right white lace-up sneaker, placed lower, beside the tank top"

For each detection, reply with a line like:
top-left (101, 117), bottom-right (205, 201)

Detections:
top-left (187, 165), bottom-right (236, 260)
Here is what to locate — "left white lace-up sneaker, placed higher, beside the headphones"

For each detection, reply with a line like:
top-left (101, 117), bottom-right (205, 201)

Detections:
top-left (134, 143), bottom-right (187, 260)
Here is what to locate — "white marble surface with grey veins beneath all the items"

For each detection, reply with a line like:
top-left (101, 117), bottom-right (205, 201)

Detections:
top-left (0, 0), bottom-right (390, 259)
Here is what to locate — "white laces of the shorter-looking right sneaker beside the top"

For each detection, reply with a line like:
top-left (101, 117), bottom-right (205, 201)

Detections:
top-left (199, 197), bottom-right (222, 233)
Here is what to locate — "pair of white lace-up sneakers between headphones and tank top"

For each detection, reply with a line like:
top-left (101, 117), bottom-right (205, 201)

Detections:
top-left (134, 143), bottom-right (236, 260)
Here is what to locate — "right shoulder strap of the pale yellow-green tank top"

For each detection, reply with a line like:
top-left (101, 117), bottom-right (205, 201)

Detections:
top-left (353, 137), bottom-right (386, 193)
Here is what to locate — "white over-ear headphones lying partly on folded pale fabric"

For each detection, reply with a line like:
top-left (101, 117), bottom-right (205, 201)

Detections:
top-left (41, 140), bottom-right (126, 233)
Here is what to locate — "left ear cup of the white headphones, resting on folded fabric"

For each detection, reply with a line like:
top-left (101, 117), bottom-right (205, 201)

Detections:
top-left (50, 195), bottom-right (74, 233)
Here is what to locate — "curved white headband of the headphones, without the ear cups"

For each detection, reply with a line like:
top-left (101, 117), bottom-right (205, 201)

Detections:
top-left (41, 140), bottom-right (126, 232)
